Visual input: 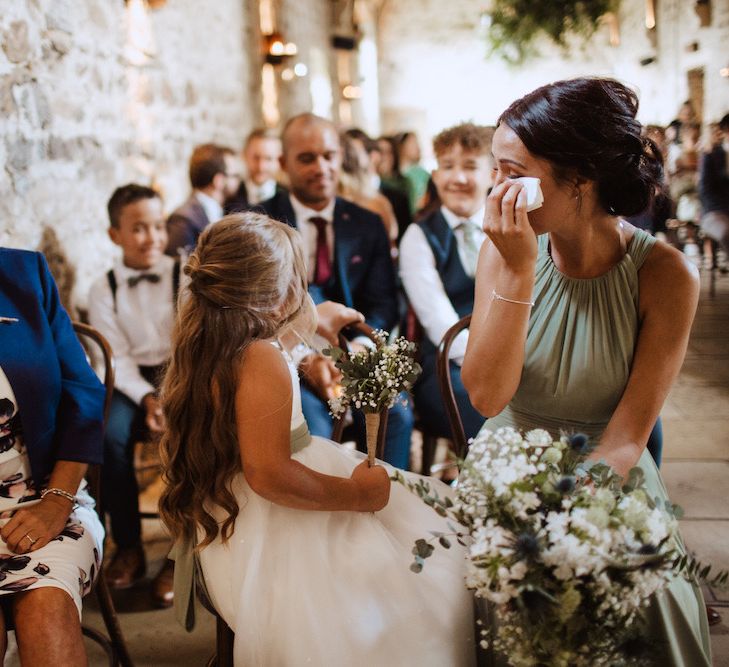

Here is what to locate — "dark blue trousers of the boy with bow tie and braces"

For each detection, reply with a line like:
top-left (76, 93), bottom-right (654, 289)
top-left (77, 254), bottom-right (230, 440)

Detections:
top-left (101, 390), bottom-right (146, 549)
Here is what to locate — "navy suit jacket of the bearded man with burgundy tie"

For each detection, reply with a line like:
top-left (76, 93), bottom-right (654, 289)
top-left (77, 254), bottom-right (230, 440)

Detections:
top-left (257, 192), bottom-right (397, 331)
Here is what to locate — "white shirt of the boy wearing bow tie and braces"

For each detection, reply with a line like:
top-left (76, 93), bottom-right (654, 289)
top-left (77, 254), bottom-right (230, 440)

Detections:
top-left (89, 255), bottom-right (175, 404)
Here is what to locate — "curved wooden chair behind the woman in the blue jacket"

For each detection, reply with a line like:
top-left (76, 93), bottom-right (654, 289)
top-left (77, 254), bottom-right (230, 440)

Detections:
top-left (73, 322), bottom-right (134, 667)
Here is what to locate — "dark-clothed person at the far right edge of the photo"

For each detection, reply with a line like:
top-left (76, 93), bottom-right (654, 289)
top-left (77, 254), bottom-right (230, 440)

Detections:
top-left (699, 114), bottom-right (729, 258)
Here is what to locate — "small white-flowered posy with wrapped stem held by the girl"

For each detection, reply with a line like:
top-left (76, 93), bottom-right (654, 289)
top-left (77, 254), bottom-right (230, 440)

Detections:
top-left (324, 330), bottom-right (421, 465)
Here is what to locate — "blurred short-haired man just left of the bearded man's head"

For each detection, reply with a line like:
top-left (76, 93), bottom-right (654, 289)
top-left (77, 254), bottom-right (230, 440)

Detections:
top-left (225, 128), bottom-right (285, 213)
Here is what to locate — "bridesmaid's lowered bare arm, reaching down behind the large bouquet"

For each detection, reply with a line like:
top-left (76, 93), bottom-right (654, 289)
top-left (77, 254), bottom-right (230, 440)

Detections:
top-left (590, 243), bottom-right (699, 476)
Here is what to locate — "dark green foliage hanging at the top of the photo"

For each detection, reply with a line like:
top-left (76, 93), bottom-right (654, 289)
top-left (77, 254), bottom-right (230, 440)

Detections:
top-left (486, 0), bottom-right (620, 64)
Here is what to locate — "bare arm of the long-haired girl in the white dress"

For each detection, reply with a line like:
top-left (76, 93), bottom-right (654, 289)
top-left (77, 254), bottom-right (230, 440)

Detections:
top-left (236, 341), bottom-right (390, 512)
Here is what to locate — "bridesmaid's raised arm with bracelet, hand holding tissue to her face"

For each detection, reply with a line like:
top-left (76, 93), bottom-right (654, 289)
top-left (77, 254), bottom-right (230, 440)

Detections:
top-left (461, 181), bottom-right (537, 417)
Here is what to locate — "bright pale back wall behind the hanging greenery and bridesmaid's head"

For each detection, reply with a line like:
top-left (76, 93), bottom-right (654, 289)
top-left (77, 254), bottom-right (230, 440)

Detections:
top-left (378, 0), bottom-right (729, 155)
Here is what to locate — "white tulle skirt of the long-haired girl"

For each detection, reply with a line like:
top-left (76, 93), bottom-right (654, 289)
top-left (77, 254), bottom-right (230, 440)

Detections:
top-left (200, 437), bottom-right (475, 667)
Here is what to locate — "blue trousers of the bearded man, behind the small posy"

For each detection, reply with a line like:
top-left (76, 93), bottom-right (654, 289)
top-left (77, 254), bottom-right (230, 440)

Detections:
top-left (301, 384), bottom-right (413, 470)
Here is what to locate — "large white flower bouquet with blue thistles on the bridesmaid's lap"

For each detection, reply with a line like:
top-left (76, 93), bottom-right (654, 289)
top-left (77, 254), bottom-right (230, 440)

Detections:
top-left (394, 428), bottom-right (727, 667)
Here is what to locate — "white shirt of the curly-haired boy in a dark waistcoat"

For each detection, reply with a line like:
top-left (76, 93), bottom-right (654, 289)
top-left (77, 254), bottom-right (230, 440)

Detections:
top-left (400, 206), bottom-right (486, 366)
